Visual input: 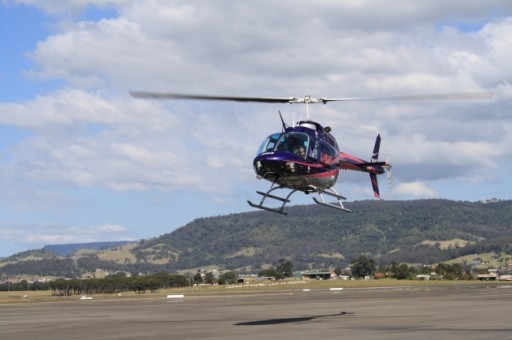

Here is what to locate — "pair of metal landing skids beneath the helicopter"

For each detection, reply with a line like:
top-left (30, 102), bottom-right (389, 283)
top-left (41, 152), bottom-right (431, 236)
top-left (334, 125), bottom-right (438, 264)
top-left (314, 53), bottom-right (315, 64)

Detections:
top-left (247, 186), bottom-right (350, 215)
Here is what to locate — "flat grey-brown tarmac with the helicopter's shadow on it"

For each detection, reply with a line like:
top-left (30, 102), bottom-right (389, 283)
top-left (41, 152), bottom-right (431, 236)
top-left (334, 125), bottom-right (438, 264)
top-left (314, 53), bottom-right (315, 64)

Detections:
top-left (0, 285), bottom-right (512, 340)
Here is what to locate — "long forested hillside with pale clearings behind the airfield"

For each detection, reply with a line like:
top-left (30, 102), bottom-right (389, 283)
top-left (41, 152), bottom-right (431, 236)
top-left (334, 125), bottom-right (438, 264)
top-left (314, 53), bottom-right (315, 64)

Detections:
top-left (0, 199), bottom-right (512, 273)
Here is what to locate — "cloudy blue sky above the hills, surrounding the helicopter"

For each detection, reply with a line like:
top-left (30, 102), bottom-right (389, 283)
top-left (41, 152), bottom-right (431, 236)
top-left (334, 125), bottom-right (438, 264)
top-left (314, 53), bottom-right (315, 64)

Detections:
top-left (0, 0), bottom-right (512, 257)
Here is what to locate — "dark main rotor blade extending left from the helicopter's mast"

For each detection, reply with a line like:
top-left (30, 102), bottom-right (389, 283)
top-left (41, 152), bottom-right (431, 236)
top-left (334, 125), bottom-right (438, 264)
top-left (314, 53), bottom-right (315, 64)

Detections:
top-left (130, 91), bottom-right (296, 103)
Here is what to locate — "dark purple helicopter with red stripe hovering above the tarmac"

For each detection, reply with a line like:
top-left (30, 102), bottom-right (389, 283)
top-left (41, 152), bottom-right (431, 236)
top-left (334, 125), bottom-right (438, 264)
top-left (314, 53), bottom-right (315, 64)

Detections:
top-left (130, 91), bottom-right (492, 215)
